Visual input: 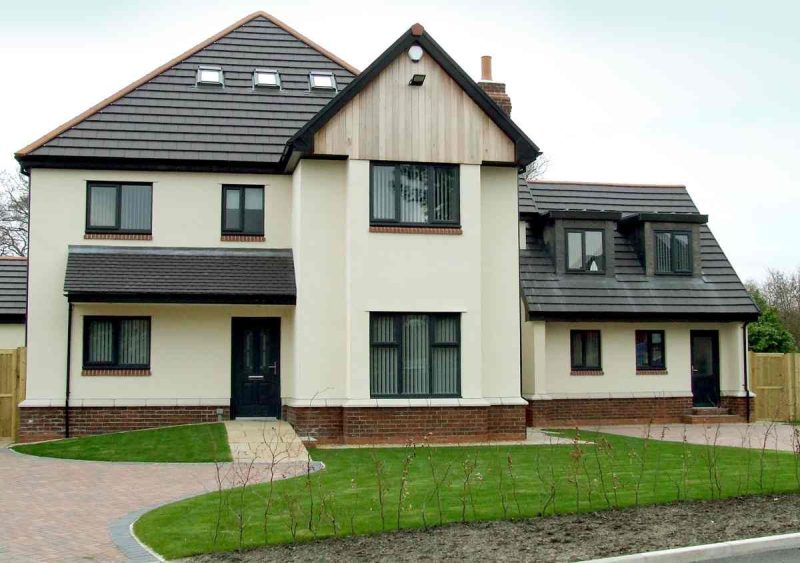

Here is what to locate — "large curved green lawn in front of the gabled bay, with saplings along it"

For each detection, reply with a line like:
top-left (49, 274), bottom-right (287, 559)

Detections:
top-left (135, 432), bottom-right (800, 559)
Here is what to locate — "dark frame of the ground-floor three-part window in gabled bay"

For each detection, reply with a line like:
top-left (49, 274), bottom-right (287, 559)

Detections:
top-left (369, 311), bottom-right (462, 399)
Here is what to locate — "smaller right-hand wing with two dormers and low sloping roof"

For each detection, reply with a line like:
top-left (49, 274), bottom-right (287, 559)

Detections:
top-left (519, 180), bottom-right (758, 425)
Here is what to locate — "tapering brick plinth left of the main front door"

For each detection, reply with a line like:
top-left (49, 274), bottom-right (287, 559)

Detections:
top-left (19, 406), bottom-right (230, 442)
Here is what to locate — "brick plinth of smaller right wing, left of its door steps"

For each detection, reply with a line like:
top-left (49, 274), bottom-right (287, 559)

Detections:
top-left (525, 397), bottom-right (692, 426)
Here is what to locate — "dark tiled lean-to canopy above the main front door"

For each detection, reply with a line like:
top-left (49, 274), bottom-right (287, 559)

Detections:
top-left (64, 245), bottom-right (297, 305)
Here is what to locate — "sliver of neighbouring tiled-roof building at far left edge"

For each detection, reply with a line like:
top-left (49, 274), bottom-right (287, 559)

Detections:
top-left (0, 256), bottom-right (28, 350)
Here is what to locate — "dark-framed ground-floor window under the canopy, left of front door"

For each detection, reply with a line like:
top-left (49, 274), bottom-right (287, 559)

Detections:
top-left (83, 317), bottom-right (150, 369)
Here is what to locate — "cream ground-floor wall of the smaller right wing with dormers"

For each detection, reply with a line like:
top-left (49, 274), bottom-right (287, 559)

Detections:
top-left (523, 321), bottom-right (744, 399)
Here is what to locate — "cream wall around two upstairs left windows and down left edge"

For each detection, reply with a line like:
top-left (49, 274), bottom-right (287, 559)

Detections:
top-left (26, 168), bottom-right (292, 404)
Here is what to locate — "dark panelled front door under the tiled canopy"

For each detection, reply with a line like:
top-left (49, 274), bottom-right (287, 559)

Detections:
top-left (231, 318), bottom-right (281, 418)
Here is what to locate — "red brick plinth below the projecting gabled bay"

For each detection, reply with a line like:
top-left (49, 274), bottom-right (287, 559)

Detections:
top-left (283, 406), bottom-right (525, 444)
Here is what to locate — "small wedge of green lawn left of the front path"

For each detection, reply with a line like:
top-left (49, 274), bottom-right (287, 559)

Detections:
top-left (13, 423), bottom-right (231, 463)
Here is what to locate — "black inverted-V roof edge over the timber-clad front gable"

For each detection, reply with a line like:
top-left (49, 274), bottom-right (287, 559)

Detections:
top-left (287, 24), bottom-right (541, 166)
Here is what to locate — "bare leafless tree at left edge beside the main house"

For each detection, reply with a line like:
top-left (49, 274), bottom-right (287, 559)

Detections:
top-left (0, 170), bottom-right (30, 256)
